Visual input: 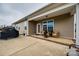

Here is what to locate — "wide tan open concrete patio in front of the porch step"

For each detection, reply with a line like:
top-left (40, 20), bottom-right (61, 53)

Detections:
top-left (0, 36), bottom-right (73, 56)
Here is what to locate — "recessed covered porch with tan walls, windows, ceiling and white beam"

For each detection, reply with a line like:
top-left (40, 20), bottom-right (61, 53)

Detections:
top-left (28, 4), bottom-right (75, 41)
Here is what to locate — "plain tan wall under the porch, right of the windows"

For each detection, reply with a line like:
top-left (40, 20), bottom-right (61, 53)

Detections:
top-left (53, 14), bottom-right (74, 39)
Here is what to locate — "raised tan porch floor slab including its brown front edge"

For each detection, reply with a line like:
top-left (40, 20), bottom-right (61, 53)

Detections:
top-left (31, 35), bottom-right (75, 46)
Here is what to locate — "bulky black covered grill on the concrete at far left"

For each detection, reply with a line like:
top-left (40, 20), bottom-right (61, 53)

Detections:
top-left (0, 27), bottom-right (19, 39)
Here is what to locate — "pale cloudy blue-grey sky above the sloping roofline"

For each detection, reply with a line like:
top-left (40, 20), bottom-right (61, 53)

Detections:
top-left (0, 3), bottom-right (48, 25)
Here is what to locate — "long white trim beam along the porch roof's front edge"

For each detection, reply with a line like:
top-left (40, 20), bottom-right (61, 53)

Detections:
top-left (28, 3), bottom-right (75, 21)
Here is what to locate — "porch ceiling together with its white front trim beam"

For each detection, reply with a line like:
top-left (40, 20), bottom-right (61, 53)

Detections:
top-left (29, 4), bottom-right (75, 21)
